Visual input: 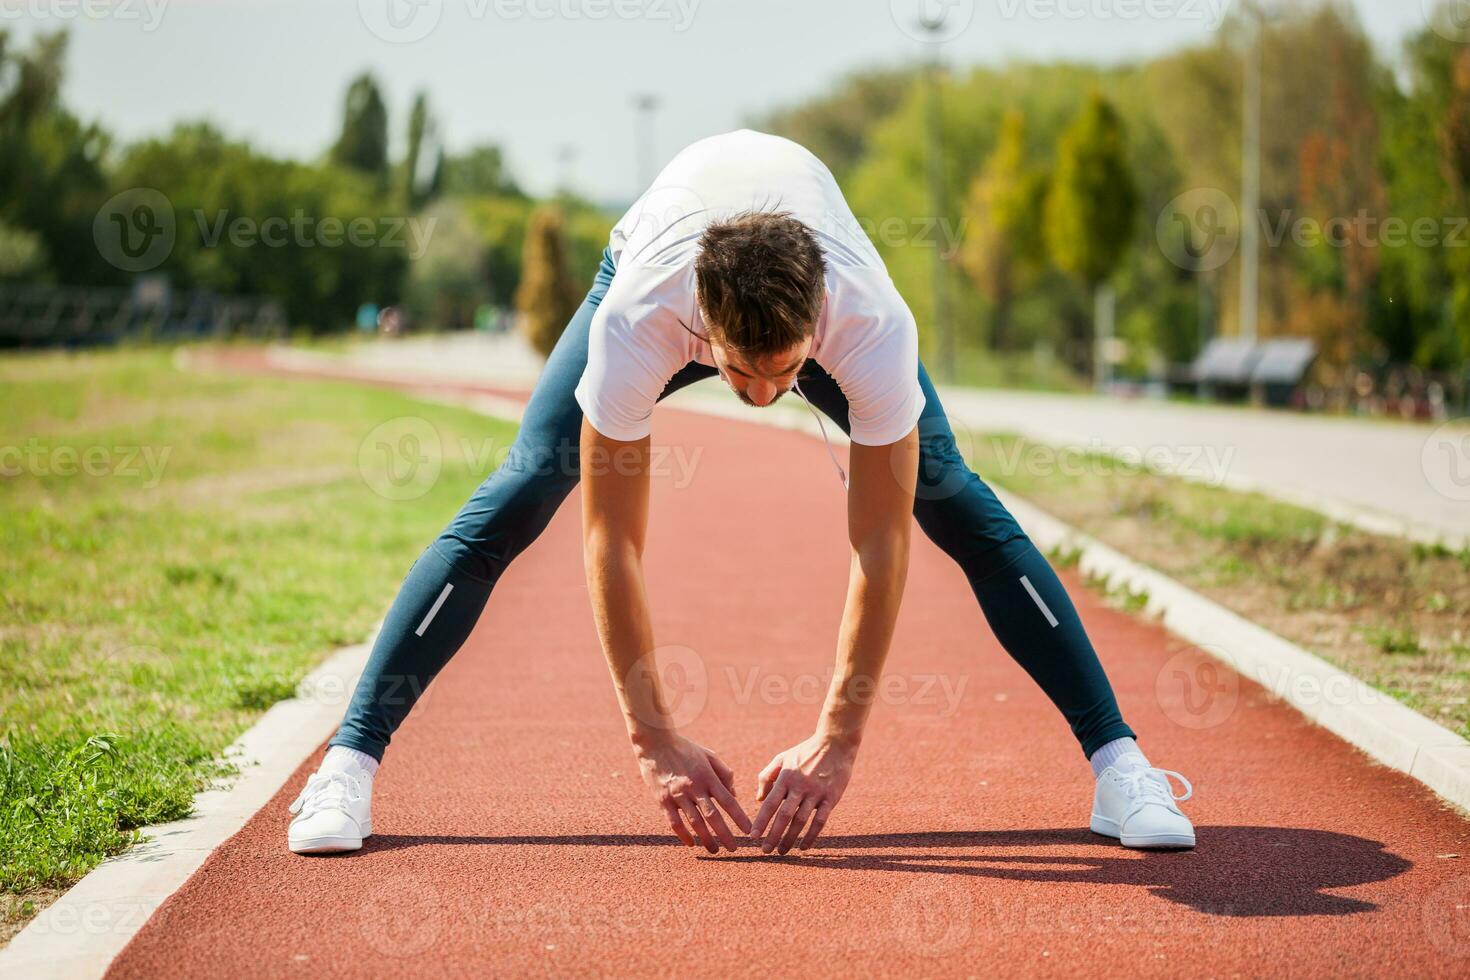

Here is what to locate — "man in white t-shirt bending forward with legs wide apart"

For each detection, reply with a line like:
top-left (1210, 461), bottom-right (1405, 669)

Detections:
top-left (288, 129), bottom-right (1195, 854)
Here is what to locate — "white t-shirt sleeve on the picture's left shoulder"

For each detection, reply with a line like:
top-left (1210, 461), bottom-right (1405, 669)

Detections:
top-left (576, 270), bottom-right (688, 442)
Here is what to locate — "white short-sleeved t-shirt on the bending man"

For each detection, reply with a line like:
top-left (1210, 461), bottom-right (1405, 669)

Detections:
top-left (576, 129), bottom-right (925, 445)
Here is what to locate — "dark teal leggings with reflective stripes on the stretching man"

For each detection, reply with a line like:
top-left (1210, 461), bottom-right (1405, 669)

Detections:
top-left (331, 253), bottom-right (1133, 760)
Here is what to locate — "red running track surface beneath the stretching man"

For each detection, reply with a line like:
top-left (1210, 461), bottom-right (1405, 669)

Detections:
top-left (109, 370), bottom-right (1470, 979)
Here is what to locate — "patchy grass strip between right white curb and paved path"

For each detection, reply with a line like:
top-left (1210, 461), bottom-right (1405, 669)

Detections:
top-left (972, 433), bottom-right (1470, 738)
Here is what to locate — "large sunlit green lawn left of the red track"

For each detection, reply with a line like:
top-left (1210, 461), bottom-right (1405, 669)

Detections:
top-left (0, 350), bottom-right (515, 915)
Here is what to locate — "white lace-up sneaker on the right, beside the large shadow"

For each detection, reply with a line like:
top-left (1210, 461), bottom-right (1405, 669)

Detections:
top-left (1092, 752), bottom-right (1194, 849)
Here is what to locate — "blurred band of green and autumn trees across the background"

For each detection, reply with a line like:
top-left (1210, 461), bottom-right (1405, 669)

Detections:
top-left (0, 0), bottom-right (1470, 390)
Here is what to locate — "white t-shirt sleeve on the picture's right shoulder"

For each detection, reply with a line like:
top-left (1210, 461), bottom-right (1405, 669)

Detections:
top-left (828, 274), bottom-right (925, 445)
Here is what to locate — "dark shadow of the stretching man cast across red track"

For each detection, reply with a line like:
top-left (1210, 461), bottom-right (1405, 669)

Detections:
top-left (357, 827), bottom-right (1413, 917)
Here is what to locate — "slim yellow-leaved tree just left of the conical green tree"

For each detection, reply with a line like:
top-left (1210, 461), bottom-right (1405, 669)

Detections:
top-left (960, 110), bottom-right (1048, 350)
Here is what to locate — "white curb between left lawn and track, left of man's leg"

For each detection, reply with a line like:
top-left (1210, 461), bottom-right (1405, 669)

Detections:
top-left (0, 642), bottom-right (372, 980)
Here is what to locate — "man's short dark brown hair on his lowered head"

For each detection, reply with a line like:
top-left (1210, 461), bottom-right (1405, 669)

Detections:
top-left (694, 212), bottom-right (826, 357)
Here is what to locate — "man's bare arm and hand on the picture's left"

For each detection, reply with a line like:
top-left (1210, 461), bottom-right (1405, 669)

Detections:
top-left (581, 420), bottom-right (750, 854)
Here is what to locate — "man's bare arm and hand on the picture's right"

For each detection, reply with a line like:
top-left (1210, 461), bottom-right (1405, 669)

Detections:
top-left (754, 429), bottom-right (919, 854)
